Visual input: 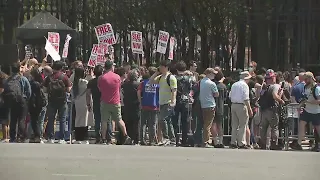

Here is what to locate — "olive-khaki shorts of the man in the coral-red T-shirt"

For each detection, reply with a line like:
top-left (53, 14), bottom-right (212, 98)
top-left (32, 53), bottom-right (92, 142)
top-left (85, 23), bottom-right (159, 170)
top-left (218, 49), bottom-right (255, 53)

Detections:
top-left (100, 102), bottom-right (122, 122)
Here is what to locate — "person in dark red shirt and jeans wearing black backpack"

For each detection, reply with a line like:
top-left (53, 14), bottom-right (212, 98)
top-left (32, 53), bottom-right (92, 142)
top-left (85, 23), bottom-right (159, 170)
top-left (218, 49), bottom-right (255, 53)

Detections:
top-left (43, 61), bottom-right (72, 144)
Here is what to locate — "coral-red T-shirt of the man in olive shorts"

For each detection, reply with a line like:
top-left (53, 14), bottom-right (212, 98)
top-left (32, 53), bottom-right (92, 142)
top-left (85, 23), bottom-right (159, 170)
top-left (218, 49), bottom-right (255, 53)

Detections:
top-left (98, 71), bottom-right (121, 105)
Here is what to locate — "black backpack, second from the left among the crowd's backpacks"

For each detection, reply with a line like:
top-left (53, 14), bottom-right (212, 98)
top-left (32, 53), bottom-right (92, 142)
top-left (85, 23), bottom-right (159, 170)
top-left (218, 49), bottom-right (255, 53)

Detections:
top-left (29, 82), bottom-right (48, 110)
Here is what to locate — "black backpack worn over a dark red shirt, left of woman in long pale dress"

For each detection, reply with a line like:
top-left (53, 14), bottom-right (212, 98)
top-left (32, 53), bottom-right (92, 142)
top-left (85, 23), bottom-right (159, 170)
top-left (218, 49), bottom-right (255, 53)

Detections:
top-left (48, 74), bottom-right (67, 106)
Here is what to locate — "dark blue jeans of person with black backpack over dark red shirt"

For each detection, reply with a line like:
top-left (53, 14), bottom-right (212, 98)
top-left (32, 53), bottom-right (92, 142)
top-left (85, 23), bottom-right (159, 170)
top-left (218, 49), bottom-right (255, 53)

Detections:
top-left (47, 103), bottom-right (68, 140)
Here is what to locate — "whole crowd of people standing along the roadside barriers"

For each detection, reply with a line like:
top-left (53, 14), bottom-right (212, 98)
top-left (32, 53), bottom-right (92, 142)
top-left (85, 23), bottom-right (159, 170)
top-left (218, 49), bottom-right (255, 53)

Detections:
top-left (0, 59), bottom-right (320, 151)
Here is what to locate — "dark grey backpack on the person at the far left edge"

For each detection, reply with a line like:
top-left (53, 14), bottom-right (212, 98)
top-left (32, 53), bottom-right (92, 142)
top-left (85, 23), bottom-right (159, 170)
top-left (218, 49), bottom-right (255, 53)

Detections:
top-left (2, 75), bottom-right (23, 106)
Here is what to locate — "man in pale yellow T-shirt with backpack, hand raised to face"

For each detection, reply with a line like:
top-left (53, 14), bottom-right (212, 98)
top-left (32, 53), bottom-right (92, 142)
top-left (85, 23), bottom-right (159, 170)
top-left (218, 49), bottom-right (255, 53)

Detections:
top-left (149, 61), bottom-right (177, 145)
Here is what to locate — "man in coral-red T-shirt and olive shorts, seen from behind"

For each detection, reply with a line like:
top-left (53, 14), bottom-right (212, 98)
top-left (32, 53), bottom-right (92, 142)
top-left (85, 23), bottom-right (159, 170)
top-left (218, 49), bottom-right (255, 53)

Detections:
top-left (98, 60), bottom-right (131, 144)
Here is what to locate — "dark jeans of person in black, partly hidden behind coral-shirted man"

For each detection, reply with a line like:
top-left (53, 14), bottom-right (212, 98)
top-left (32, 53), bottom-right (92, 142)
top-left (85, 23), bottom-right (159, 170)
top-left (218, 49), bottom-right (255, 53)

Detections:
top-left (92, 102), bottom-right (112, 141)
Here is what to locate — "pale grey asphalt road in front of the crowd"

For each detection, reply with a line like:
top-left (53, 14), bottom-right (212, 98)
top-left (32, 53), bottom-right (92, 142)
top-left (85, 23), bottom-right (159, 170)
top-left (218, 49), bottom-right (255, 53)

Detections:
top-left (0, 144), bottom-right (320, 180)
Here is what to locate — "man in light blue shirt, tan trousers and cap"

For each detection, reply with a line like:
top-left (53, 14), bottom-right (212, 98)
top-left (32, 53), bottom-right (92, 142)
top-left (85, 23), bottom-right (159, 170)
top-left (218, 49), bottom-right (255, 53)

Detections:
top-left (199, 68), bottom-right (219, 147)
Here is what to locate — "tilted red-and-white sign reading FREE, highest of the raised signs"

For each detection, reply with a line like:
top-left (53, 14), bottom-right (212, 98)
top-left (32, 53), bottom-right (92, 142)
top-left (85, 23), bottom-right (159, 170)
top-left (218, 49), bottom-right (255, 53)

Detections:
top-left (94, 23), bottom-right (116, 45)
